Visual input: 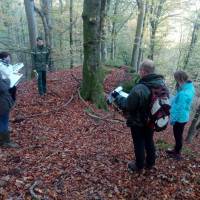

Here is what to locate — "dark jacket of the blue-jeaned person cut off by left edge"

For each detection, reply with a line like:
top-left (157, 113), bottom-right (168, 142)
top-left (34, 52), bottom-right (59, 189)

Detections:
top-left (0, 74), bottom-right (14, 115)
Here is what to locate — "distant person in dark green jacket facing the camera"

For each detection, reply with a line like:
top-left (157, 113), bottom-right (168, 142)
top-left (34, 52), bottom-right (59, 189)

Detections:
top-left (31, 37), bottom-right (50, 96)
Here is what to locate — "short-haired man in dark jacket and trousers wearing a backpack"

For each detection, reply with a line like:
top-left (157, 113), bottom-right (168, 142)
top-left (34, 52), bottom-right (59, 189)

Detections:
top-left (113, 60), bottom-right (165, 172)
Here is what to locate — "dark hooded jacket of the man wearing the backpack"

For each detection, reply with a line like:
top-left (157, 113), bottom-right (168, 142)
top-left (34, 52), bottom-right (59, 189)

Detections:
top-left (115, 74), bottom-right (165, 127)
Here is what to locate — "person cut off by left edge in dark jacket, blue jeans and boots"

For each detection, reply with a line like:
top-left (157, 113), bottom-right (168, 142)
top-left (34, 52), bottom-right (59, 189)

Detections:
top-left (0, 73), bottom-right (18, 147)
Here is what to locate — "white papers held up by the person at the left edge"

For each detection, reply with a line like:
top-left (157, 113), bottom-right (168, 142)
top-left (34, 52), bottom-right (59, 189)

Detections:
top-left (0, 62), bottom-right (24, 87)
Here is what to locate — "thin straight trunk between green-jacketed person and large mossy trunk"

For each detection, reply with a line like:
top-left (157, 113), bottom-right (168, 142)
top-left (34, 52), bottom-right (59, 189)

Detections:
top-left (69, 0), bottom-right (74, 68)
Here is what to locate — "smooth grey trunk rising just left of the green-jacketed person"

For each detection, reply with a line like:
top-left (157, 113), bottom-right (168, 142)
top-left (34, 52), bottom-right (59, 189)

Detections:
top-left (24, 0), bottom-right (37, 78)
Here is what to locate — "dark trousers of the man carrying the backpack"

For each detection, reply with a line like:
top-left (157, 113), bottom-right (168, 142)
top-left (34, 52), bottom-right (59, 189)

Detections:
top-left (131, 126), bottom-right (156, 169)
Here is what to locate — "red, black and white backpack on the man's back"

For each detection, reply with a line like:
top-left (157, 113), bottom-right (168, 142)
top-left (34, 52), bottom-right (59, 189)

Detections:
top-left (147, 85), bottom-right (171, 132)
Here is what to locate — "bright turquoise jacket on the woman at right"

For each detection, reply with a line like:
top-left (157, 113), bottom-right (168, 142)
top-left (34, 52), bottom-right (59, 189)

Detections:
top-left (170, 81), bottom-right (195, 125)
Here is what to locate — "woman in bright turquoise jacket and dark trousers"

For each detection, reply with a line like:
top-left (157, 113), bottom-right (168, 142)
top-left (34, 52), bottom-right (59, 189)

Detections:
top-left (167, 71), bottom-right (195, 159)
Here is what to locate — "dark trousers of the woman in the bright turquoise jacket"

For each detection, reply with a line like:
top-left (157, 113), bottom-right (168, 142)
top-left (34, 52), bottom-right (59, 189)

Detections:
top-left (173, 122), bottom-right (186, 153)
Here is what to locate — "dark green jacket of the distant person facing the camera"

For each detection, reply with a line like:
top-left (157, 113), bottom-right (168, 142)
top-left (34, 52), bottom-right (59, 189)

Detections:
top-left (31, 46), bottom-right (50, 71)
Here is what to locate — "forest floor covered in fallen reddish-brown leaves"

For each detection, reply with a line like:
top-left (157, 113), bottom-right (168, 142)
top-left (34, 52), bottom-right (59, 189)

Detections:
top-left (0, 67), bottom-right (200, 200)
